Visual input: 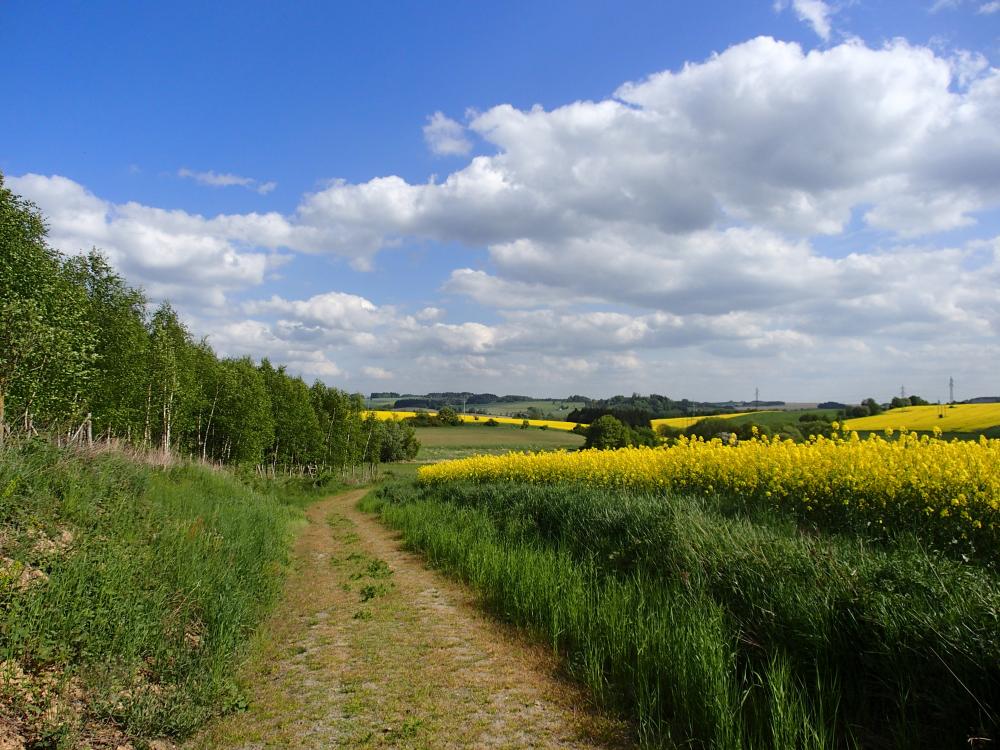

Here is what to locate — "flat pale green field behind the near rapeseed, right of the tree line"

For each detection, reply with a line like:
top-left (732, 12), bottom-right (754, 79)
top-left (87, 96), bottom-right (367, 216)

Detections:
top-left (416, 422), bottom-right (584, 462)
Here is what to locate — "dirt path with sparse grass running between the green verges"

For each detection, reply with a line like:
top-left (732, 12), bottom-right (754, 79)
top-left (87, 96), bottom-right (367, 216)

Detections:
top-left (190, 490), bottom-right (628, 750)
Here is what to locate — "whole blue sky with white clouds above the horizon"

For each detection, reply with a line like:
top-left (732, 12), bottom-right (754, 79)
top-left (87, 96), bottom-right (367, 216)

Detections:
top-left (0, 0), bottom-right (1000, 401)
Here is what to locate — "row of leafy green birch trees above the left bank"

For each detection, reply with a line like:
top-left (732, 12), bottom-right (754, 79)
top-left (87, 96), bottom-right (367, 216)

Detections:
top-left (0, 174), bottom-right (419, 473)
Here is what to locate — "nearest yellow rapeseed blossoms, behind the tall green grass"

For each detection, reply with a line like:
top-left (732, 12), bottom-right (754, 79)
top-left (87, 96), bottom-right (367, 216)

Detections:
top-left (419, 432), bottom-right (1000, 555)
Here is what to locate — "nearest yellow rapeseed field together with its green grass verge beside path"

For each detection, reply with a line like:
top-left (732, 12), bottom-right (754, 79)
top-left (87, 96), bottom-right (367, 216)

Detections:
top-left (366, 434), bottom-right (1000, 748)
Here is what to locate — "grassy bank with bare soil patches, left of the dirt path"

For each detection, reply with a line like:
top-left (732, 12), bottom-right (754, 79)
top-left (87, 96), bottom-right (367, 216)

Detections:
top-left (0, 441), bottom-right (322, 747)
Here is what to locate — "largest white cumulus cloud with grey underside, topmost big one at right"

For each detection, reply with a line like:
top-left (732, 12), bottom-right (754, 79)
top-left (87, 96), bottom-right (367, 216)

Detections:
top-left (299, 38), bottom-right (1000, 253)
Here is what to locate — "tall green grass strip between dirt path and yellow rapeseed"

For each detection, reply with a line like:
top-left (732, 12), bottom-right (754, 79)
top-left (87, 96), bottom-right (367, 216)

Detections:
top-left (367, 482), bottom-right (1000, 748)
